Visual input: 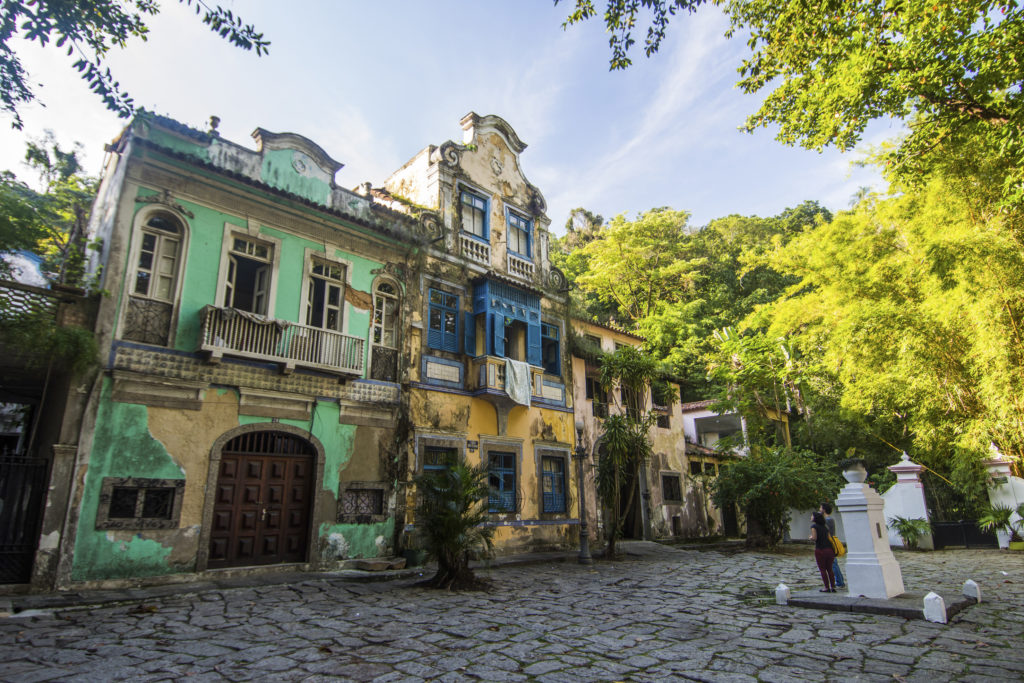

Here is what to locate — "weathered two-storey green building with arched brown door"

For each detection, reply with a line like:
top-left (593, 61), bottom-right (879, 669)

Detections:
top-left (54, 113), bottom-right (436, 587)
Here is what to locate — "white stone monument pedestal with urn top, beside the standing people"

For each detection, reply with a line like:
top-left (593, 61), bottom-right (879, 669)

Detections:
top-left (836, 464), bottom-right (903, 599)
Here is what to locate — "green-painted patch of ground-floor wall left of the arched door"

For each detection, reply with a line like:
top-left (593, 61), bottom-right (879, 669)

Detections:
top-left (72, 378), bottom-right (190, 581)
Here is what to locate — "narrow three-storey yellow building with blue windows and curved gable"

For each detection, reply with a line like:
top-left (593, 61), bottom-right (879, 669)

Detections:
top-left (380, 113), bottom-right (579, 553)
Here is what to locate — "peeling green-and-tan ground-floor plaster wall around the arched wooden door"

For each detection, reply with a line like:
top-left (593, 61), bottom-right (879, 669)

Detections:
top-left (72, 379), bottom-right (394, 581)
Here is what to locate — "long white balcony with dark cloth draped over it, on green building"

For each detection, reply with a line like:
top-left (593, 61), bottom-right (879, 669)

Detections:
top-left (199, 306), bottom-right (367, 377)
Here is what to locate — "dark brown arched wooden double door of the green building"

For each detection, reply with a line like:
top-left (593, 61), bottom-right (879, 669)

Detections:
top-left (207, 431), bottom-right (316, 568)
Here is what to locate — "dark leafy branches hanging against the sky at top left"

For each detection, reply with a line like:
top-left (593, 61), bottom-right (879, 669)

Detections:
top-left (0, 0), bottom-right (270, 129)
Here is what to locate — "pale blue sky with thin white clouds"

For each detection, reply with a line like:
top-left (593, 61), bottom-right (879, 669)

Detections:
top-left (0, 0), bottom-right (898, 233)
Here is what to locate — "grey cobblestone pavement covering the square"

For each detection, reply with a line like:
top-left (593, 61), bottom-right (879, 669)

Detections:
top-left (0, 544), bottom-right (1024, 683)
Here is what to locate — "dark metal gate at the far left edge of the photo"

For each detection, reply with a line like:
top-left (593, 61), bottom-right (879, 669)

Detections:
top-left (0, 453), bottom-right (49, 584)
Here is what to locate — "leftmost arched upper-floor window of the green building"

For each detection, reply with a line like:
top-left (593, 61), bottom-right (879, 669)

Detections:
top-left (121, 210), bottom-right (186, 346)
